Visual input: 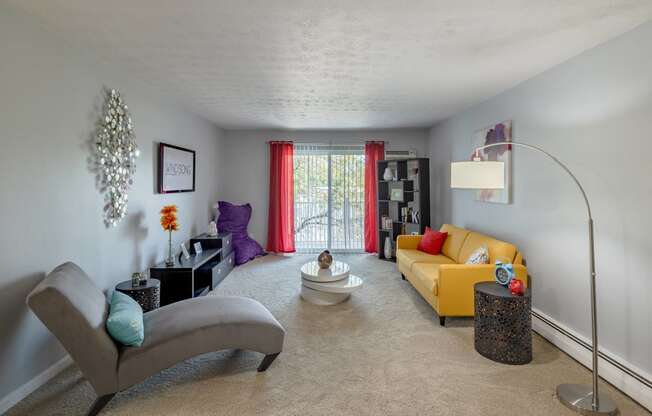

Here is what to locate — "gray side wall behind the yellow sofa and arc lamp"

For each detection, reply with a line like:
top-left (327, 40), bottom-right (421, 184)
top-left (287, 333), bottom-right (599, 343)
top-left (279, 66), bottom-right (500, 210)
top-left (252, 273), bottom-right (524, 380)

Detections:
top-left (429, 23), bottom-right (652, 374)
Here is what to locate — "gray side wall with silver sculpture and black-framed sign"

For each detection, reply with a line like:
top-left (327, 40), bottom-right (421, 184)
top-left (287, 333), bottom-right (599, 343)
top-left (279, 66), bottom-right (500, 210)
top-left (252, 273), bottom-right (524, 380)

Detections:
top-left (0, 5), bottom-right (223, 399)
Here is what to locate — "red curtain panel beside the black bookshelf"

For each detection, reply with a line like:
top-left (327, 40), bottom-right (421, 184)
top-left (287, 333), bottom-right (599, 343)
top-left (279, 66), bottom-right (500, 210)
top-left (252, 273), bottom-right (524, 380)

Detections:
top-left (364, 142), bottom-right (385, 253)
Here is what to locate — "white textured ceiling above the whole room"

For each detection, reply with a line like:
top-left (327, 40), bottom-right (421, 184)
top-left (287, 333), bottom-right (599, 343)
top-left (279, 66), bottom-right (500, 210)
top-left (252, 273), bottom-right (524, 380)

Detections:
top-left (7, 0), bottom-right (652, 129)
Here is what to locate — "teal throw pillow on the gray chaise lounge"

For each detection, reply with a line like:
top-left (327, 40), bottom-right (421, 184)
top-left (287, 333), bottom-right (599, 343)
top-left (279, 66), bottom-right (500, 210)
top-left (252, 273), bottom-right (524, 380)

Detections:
top-left (106, 290), bottom-right (145, 347)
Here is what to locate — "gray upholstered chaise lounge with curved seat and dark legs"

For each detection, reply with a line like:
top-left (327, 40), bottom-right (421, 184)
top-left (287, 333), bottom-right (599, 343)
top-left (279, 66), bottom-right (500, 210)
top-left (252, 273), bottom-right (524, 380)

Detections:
top-left (27, 263), bottom-right (285, 415)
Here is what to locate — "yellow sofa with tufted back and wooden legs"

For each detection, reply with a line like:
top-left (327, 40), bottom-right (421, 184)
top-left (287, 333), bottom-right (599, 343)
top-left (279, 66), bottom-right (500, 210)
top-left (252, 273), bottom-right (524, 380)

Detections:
top-left (396, 224), bottom-right (528, 326)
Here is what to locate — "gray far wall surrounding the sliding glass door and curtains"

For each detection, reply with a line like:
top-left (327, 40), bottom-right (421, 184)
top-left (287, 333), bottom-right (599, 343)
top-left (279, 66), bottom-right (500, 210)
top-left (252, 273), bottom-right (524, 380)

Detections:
top-left (220, 129), bottom-right (428, 247)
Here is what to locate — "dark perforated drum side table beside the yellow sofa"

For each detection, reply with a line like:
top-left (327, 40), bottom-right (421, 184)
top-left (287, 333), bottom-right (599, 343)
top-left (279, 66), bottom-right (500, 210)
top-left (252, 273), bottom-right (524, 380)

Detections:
top-left (474, 282), bottom-right (532, 364)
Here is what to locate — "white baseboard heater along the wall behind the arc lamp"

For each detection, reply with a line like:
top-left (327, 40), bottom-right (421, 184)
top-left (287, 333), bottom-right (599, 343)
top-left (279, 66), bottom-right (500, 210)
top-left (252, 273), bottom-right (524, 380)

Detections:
top-left (532, 308), bottom-right (652, 411)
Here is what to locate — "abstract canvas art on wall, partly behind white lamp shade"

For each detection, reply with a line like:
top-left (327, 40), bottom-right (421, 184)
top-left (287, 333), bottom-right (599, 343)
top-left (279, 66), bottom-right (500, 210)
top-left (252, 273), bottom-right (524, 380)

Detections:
top-left (473, 120), bottom-right (512, 204)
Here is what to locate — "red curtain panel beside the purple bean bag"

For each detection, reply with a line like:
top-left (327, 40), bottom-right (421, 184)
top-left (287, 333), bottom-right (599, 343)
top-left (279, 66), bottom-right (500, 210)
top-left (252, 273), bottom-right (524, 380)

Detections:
top-left (267, 142), bottom-right (295, 253)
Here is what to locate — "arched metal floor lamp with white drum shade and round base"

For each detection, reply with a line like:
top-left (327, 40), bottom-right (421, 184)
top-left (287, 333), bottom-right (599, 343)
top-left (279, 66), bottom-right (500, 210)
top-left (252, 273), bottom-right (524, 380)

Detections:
top-left (451, 142), bottom-right (618, 416)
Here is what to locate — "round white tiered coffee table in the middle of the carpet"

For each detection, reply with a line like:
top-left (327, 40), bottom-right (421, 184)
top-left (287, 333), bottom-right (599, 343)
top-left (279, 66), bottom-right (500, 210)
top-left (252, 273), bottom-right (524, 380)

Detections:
top-left (301, 261), bottom-right (362, 305)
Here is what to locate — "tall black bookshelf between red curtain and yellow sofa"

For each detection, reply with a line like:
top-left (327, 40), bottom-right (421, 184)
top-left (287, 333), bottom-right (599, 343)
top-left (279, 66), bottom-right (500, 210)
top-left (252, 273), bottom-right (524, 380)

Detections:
top-left (376, 158), bottom-right (430, 260)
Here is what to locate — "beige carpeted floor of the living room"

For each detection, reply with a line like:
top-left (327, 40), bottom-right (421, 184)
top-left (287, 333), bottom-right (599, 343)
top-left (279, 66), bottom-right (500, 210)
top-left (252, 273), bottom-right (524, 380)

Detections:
top-left (8, 255), bottom-right (650, 416)
